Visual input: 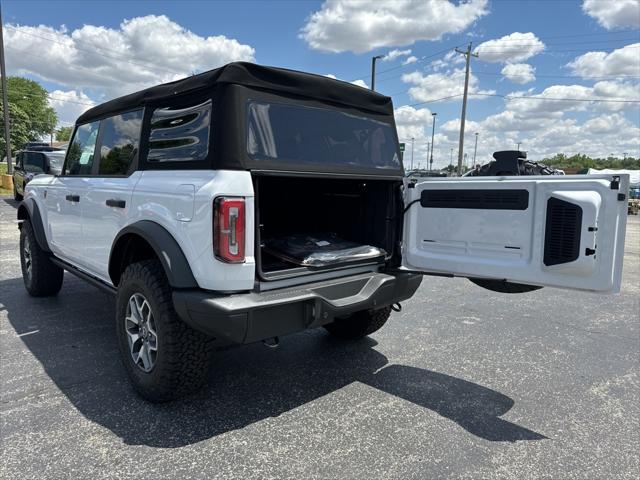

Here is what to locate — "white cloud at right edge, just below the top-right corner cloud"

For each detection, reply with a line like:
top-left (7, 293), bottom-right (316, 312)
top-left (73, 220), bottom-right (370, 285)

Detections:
top-left (567, 43), bottom-right (640, 78)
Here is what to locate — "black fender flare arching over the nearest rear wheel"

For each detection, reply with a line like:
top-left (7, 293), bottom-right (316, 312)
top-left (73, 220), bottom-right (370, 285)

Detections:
top-left (109, 220), bottom-right (198, 288)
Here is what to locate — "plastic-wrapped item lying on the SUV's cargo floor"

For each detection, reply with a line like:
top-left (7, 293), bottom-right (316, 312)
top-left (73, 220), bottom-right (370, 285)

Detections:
top-left (264, 233), bottom-right (386, 269)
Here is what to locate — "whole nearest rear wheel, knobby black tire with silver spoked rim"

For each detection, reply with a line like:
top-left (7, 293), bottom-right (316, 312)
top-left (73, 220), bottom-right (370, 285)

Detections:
top-left (116, 260), bottom-right (212, 403)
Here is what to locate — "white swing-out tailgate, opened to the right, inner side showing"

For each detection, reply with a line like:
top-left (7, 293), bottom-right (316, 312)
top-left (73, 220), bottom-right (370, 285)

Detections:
top-left (403, 175), bottom-right (629, 293)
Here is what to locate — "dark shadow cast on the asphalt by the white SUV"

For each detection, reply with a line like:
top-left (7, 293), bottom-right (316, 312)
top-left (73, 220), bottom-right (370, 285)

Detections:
top-left (0, 274), bottom-right (546, 448)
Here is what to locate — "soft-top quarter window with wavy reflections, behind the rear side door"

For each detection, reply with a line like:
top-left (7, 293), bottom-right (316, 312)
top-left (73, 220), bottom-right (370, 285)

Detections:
top-left (147, 100), bottom-right (211, 163)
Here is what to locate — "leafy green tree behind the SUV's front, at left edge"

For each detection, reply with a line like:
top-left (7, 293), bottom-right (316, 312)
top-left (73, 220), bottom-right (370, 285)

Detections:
top-left (0, 77), bottom-right (58, 157)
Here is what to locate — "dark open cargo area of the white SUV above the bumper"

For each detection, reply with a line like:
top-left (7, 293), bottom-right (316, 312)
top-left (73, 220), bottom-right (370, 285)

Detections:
top-left (254, 175), bottom-right (402, 280)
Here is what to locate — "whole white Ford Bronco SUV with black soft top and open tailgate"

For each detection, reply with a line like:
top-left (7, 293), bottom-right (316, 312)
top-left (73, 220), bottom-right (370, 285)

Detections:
top-left (18, 63), bottom-right (628, 402)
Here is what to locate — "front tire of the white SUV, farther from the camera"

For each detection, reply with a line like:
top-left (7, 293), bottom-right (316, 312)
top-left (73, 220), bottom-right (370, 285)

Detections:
top-left (20, 220), bottom-right (64, 297)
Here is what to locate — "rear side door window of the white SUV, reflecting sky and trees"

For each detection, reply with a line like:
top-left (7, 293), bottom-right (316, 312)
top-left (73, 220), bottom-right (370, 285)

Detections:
top-left (98, 110), bottom-right (142, 175)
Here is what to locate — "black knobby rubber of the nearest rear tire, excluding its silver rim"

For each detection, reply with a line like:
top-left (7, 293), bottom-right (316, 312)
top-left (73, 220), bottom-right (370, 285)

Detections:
top-left (116, 260), bottom-right (212, 403)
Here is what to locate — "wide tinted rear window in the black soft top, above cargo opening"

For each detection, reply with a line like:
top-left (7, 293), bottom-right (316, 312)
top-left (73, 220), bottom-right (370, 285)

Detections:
top-left (247, 102), bottom-right (400, 169)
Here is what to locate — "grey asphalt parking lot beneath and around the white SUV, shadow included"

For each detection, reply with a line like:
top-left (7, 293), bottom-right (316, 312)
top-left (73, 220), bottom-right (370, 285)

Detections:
top-left (0, 199), bottom-right (640, 480)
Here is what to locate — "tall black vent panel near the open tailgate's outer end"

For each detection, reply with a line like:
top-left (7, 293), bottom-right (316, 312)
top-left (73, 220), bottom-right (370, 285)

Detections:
top-left (544, 197), bottom-right (582, 265)
